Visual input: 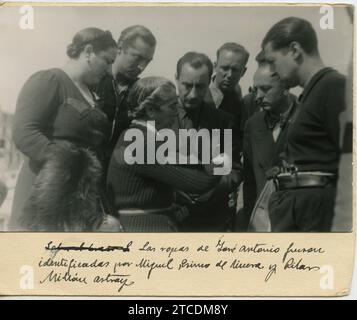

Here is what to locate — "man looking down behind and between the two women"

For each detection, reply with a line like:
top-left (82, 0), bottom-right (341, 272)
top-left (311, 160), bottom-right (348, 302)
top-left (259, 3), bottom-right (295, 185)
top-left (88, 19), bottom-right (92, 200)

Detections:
top-left (96, 25), bottom-right (156, 168)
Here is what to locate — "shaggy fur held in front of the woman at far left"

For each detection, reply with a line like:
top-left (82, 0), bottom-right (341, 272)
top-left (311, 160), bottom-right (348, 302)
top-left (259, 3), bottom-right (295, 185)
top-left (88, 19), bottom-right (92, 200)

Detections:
top-left (21, 141), bottom-right (104, 231)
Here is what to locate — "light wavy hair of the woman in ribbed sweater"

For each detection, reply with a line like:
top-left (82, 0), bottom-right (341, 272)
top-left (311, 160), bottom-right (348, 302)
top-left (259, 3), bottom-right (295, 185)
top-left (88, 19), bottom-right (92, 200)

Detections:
top-left (128, 77), bottom-right (176, 119)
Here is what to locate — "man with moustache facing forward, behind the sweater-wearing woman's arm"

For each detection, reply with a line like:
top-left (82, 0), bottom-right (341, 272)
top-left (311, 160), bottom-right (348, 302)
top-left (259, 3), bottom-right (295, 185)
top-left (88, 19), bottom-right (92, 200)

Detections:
top-left (173, 52), bottom-right (235, 231)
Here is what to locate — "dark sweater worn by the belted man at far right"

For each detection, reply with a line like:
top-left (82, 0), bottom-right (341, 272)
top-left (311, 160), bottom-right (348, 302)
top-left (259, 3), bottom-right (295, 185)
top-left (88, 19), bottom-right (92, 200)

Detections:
top-left (286, 68), bottom-right (346, 173)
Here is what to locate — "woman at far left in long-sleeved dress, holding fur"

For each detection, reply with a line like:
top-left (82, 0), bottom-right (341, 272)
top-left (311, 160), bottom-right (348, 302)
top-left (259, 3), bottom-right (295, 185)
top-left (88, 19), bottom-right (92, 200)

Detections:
top-left (10, 28), bottom-right (117, 231)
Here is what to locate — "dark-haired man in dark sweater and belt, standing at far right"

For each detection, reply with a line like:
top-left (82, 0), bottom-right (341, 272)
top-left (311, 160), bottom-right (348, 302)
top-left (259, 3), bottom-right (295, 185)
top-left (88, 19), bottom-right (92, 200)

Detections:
top-left (262, 17), bottom-right (344, 232)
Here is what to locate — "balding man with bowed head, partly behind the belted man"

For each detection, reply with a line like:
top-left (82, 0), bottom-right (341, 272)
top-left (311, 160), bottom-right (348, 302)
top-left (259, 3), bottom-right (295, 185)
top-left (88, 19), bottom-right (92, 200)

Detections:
top-left (238, 64), bottom-right (296, 231)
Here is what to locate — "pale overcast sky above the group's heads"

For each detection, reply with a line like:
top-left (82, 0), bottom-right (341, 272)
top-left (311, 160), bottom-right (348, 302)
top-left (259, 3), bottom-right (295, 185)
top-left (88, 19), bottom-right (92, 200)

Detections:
top-left (0, 5), bottom-right (352, 112)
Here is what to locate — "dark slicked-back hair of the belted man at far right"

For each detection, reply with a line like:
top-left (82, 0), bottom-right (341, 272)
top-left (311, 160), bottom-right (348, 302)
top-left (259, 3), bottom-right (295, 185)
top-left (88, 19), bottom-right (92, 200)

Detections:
top-left (262, 17), bottom-right (318, 54)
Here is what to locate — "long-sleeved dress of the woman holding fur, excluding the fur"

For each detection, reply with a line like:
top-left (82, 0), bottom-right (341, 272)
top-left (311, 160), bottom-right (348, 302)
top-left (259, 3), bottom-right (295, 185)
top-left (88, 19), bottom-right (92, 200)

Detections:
top-left (10, 69), bottom-right (110, 230)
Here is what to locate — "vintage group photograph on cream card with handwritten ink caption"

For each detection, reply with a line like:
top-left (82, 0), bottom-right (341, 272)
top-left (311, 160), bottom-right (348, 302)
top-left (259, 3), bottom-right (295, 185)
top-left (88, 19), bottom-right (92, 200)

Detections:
top-left (0, 3), bottom-right (354, 295)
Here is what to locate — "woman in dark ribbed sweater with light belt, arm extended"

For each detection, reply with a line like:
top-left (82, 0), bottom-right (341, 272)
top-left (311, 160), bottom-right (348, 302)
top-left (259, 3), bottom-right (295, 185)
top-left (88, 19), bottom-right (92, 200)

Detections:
top-left (107, 77), bottom-right (220, 232)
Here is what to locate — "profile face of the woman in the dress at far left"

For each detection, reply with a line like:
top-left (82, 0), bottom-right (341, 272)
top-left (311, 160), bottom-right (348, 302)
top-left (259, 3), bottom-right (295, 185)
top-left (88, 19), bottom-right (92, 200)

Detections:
top-left (86, 47), bottom-right (117, 84)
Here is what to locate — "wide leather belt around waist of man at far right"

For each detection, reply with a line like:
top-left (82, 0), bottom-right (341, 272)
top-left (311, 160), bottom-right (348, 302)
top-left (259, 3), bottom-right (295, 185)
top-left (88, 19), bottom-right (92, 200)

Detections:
top-left (274, 172), bottom-right (337, 190)
